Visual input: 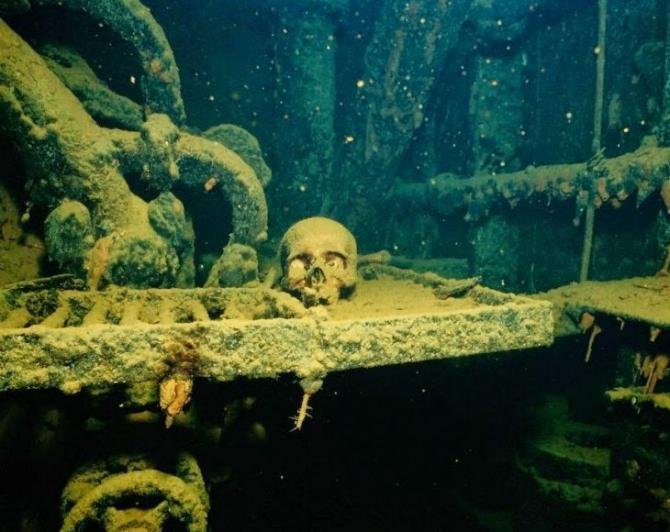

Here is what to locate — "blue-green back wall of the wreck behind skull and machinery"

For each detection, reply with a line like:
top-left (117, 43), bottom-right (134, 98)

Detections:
top-left (0, 0), bottom-right (668, 290)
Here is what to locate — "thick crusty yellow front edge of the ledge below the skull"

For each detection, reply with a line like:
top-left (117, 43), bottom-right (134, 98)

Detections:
top-left (0, 288), bottom-right (553, 392)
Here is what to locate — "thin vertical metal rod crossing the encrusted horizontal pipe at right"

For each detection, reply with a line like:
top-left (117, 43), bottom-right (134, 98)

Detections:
top-left (579, 0), bottom-right (607, 281)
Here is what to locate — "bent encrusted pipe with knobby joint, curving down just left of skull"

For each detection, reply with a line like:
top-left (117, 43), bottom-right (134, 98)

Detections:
top-left (35, 45), bottom-right (271, 246)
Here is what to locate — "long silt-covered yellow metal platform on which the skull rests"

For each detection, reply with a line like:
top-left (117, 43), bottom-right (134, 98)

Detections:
top-left (0, 278), bottom-right (553, 393)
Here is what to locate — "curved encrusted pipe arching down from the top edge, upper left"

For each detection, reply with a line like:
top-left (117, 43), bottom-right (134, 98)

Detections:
top-left (31, 0), bottom-right (186, 124)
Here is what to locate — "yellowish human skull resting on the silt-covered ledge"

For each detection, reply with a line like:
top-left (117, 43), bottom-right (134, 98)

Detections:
top-left (279, 216), bottom-right (357, 306)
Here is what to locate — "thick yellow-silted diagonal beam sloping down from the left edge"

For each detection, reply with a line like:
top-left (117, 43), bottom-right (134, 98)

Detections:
top-left (0, 20), bottom-right (139, 222)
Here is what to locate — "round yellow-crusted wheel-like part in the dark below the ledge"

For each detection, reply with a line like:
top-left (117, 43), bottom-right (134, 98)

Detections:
top-left (61, 453), bottom-right (209, 532)
